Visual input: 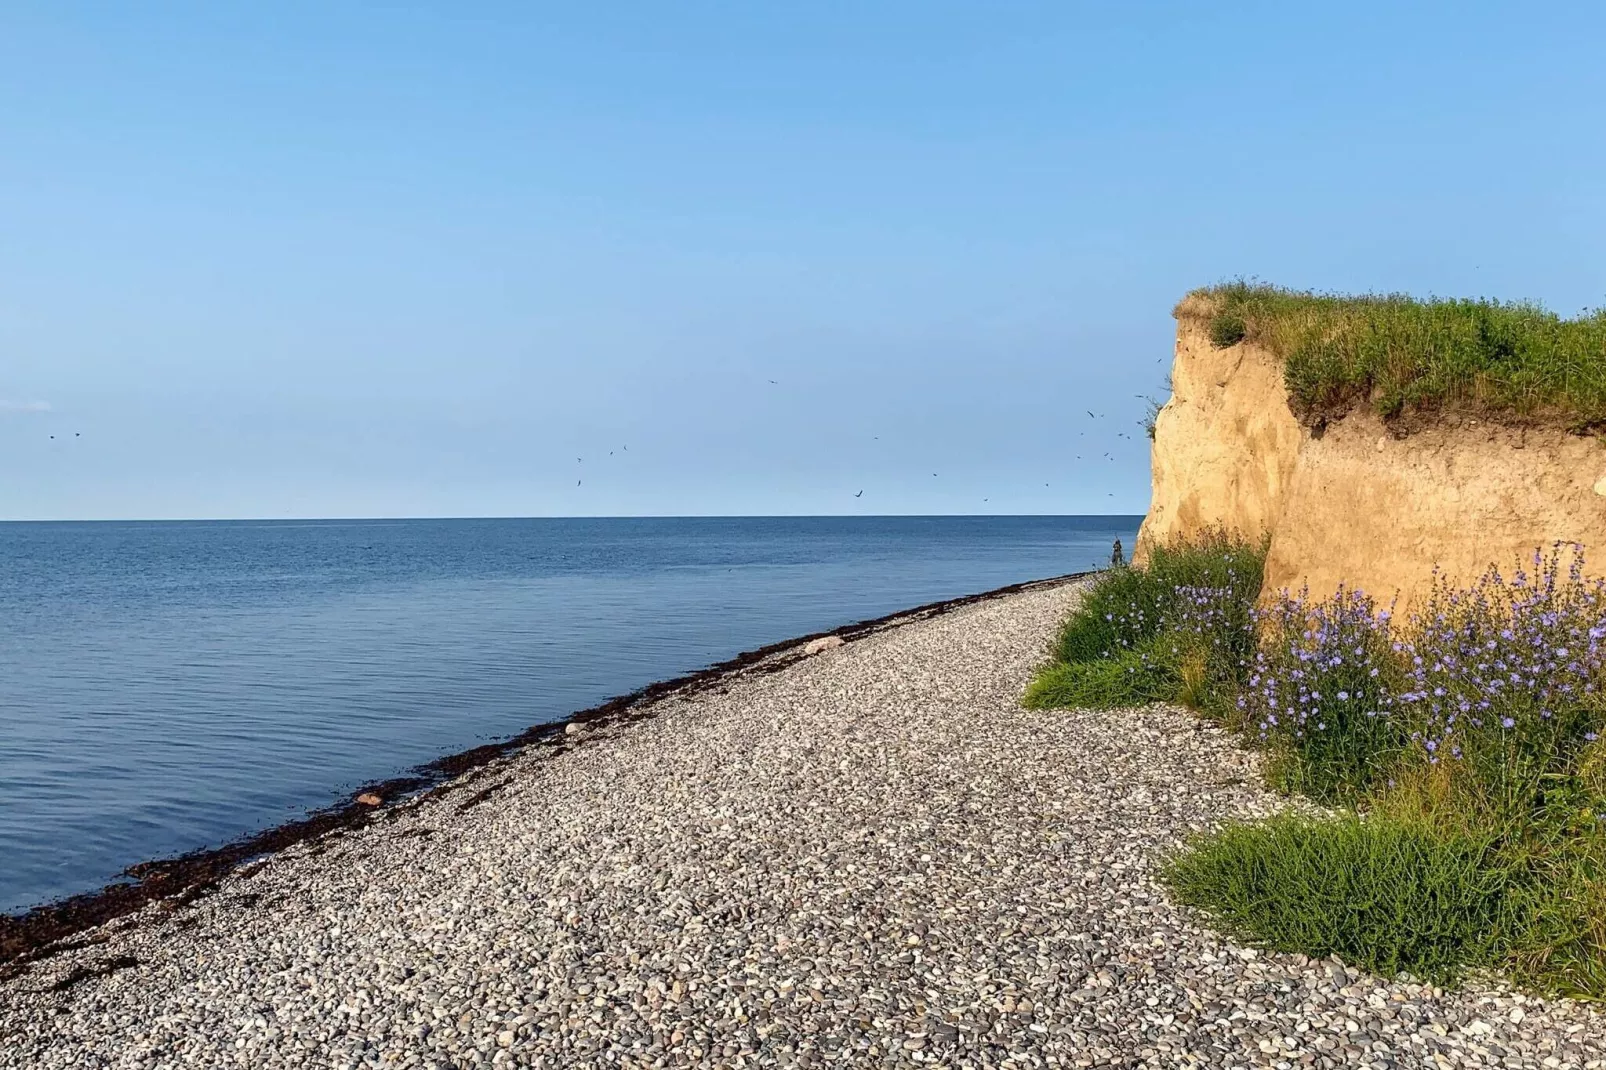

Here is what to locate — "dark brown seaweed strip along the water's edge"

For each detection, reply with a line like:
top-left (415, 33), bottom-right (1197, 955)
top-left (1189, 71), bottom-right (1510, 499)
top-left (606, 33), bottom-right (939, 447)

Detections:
top-left (0, 572), bottom-right (1092, 963)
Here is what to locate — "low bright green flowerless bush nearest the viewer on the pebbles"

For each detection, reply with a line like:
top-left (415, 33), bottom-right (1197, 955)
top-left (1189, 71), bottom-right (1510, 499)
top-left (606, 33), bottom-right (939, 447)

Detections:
top-left (1161, 815), bottom-right (1513, 985)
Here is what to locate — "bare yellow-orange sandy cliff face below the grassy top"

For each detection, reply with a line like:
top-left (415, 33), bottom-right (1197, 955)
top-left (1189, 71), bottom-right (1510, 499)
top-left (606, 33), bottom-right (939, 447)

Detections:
top-left (1137, 317), bottom-right (1606, 609)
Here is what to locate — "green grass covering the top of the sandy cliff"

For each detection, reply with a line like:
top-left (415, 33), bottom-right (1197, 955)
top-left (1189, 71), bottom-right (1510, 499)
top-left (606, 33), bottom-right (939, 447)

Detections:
top-left (1177, 283), bottom-right (1606, 429)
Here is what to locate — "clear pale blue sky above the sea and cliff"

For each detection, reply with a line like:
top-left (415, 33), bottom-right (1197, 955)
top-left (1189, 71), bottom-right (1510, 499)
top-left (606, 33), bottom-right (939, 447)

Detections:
top-left (0, 2), bottom-right (1606, 519)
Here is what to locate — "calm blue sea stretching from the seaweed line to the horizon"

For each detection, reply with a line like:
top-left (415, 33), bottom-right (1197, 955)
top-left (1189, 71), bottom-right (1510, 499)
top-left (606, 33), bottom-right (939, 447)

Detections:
top-left (0, 516), bottom-right (1140, 911)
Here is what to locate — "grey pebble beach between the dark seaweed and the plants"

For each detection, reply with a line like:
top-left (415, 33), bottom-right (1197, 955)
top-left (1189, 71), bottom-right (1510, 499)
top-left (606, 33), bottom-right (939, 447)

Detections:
top-left (0, 585), bottom-right (1606, 1068)
